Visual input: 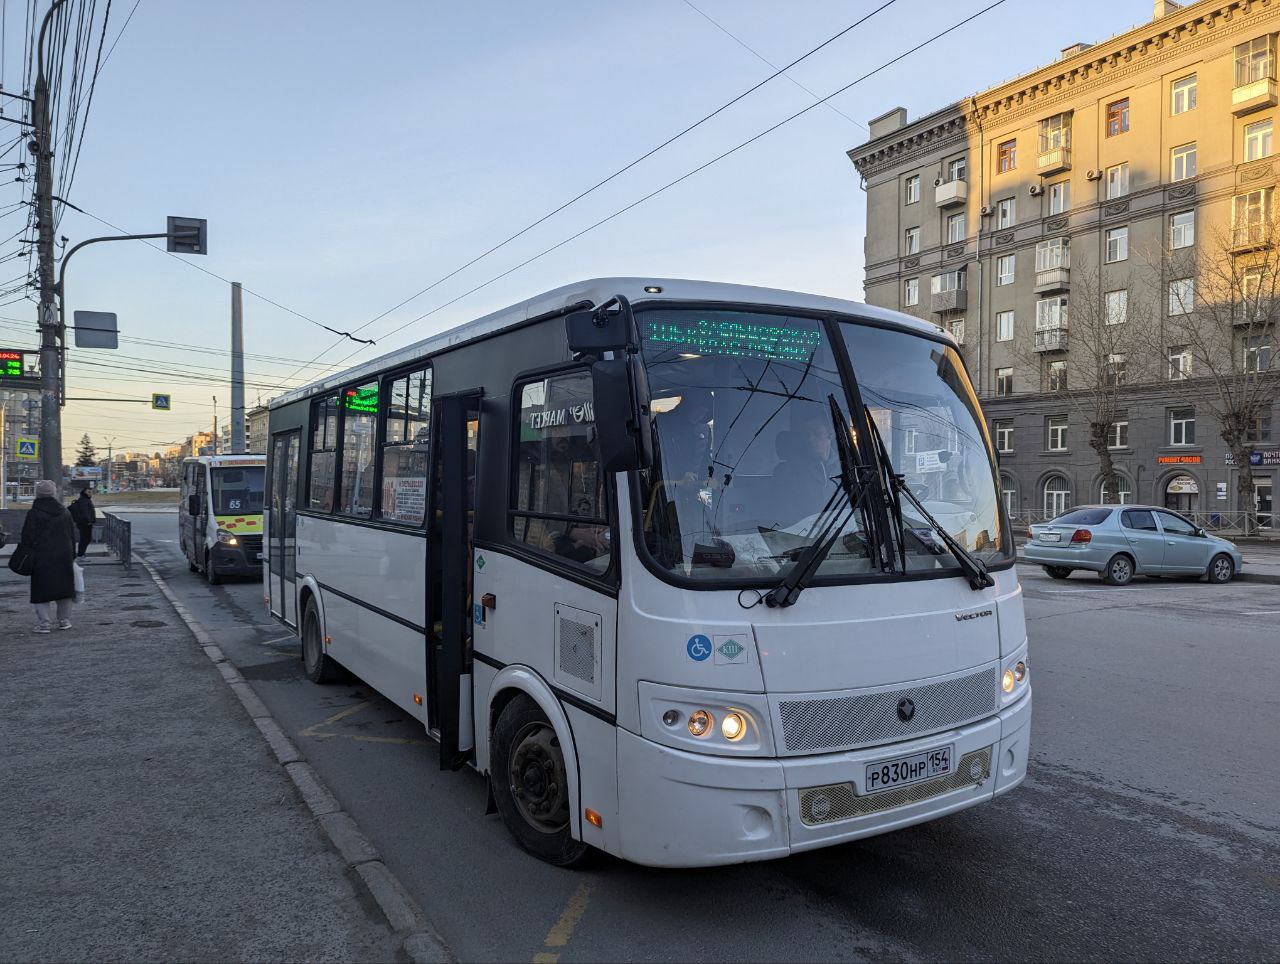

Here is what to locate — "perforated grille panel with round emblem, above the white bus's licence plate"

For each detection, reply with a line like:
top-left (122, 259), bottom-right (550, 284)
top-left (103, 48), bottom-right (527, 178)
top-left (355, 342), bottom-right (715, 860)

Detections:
top-left (778, 667), bottom-right (996, 753)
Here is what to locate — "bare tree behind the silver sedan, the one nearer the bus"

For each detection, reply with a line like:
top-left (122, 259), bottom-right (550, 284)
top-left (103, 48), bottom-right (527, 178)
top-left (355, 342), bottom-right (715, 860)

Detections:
top-left (1014, 259), bottom-right (1155, 503)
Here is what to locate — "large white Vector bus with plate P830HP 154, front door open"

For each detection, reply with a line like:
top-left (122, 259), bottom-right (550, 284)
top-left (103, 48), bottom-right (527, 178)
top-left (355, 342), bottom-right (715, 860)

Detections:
top-left (265, 278), bottom-right (1032, 867)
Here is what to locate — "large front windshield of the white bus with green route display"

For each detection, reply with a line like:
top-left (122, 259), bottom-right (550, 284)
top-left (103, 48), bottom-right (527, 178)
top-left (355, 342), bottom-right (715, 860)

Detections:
top-left (637, 309), bottom-right (1006, 584)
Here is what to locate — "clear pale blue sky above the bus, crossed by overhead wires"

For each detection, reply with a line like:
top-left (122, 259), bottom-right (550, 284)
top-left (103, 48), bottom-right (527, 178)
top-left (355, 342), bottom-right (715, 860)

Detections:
top-left (0, 0), bottom-right (1151, 457)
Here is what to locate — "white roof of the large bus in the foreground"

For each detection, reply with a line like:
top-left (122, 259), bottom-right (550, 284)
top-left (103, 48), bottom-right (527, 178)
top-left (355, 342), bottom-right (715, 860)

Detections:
top-left (269, 278), bottom-right (938, 408)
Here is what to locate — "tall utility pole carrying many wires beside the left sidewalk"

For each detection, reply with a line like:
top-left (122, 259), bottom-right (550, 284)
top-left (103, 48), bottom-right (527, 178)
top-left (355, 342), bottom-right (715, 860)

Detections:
top-left (31, 0), bottom-right (67, 481)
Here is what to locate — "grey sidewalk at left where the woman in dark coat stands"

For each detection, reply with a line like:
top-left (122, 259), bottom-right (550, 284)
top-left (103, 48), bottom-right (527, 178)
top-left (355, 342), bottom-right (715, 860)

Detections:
top-left (0, 559), bottom-right (403, 960)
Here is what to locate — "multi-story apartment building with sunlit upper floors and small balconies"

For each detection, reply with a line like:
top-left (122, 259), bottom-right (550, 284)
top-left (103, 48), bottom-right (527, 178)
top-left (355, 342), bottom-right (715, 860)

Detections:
top-left (849, 0), bottom-right (1280, 525)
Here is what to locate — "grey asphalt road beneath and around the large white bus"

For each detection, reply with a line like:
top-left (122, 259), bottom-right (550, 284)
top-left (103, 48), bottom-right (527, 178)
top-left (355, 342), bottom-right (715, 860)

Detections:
top-left (128, 513), bottom-right (1280, 961)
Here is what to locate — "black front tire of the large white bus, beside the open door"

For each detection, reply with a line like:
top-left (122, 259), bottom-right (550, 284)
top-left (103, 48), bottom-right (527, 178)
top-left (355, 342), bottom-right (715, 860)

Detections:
top-left (489, 695), bottom-right (591, 867)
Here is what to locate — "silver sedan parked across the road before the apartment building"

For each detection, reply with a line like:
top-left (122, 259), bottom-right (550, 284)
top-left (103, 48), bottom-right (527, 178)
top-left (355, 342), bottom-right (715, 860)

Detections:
top-left (1023, 506), bottom-right (1244, 586)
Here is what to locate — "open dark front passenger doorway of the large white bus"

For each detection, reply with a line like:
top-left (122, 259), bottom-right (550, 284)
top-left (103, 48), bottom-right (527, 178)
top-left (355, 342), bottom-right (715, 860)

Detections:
top-left (426, 393), bottom-right (480, 769)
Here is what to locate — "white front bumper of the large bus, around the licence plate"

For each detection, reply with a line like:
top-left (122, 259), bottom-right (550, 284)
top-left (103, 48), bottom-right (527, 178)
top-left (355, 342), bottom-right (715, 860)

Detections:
top-left (617, 690), bottom-right (1032, 867)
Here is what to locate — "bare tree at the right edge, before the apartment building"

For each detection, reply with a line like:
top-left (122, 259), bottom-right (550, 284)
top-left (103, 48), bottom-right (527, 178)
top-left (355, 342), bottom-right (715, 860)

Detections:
top-left (1148, 209), bottom-right (1280, 533)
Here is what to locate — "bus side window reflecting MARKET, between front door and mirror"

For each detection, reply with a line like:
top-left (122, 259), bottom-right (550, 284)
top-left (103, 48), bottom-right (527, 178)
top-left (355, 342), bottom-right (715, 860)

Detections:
top-left (511, 371), bottom-right (611, 574)
